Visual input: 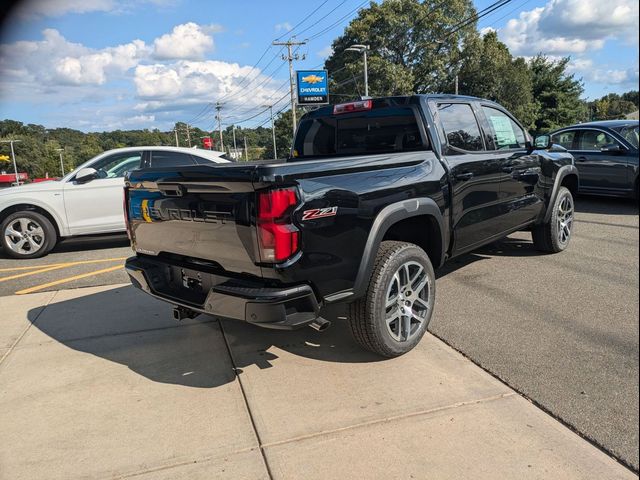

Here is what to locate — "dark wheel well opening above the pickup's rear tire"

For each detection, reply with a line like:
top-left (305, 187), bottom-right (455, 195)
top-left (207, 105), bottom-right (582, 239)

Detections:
top-left (382, 215), bottom-right (442, 268)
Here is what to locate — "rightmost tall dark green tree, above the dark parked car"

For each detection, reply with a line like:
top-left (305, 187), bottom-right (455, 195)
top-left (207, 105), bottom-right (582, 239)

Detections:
top-left (529, 55), bottom-right (587, 133)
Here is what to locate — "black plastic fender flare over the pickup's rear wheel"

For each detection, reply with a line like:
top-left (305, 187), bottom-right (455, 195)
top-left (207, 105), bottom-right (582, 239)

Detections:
top-left (324, 198), bottom-right (447, 303)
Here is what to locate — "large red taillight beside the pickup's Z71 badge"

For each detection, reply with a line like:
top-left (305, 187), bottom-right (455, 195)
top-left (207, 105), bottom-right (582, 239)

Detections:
top-left (258, 188), bottom-right (300, 262)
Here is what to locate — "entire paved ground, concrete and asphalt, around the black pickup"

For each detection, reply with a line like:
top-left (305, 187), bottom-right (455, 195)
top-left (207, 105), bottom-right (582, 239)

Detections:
top-left (0, 198), bottom-right (638, 478)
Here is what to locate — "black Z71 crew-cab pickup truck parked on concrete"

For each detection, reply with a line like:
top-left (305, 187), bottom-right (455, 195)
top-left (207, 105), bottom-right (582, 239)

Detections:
top-left (125, 95), bottom-right (578, 357)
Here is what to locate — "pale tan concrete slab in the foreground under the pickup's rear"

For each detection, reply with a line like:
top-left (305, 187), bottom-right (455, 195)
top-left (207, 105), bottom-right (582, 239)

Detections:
top-left (0, 285), bottom-right (637, 480)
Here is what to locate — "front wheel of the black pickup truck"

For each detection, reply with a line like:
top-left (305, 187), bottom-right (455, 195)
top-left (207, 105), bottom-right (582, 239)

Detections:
top-left (531, 187), bottom-right (574, 253)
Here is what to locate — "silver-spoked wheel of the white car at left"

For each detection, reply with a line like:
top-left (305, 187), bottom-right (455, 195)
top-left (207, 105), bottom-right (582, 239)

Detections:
top-left (0, 210), bottom-right (58, 258)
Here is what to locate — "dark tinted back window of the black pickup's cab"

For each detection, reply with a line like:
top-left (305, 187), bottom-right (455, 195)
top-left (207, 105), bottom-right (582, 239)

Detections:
top-left (294, 107), bottom-right (425, 158)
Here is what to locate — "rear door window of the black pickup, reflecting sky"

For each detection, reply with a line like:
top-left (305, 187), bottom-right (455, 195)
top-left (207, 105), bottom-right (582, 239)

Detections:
top-left (438, 103), bottom-right (484, 152)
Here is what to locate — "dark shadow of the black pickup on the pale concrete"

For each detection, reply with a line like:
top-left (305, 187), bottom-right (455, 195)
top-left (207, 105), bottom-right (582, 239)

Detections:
top-left (28, 286), bottom-right (383, 388)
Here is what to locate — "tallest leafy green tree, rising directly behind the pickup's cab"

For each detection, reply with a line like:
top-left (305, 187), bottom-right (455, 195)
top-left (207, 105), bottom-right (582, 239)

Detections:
top-left (325, 0), bottom-right (476, 102)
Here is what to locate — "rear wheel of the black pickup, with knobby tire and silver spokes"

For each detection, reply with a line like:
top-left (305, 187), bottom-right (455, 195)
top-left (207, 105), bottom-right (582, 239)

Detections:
top-left (348, 241), bottom-right (436, 358)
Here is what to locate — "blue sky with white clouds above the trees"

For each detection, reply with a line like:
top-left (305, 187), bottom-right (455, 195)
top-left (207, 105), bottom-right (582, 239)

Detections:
top-left (0, 0), bottom-right (638, 131)
